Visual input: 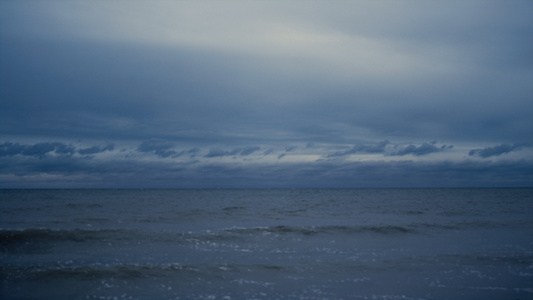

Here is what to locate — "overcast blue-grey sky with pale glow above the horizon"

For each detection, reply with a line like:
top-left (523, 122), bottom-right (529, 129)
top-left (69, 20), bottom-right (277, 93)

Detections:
top-left (0, 0), bottom-right (533, 188)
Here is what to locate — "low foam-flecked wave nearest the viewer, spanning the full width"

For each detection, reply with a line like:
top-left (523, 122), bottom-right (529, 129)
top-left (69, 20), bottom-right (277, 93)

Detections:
top-left (4, 253), bottom-right (533, 280)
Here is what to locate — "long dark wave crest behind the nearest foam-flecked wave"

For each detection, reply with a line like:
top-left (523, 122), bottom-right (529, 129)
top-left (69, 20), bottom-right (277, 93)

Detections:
top-left (0, 225), bottom-right (414, 254)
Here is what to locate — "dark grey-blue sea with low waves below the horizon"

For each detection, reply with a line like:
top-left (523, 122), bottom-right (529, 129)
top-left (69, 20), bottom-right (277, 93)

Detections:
top-left (0, 189), bottom-right (533, 299)
